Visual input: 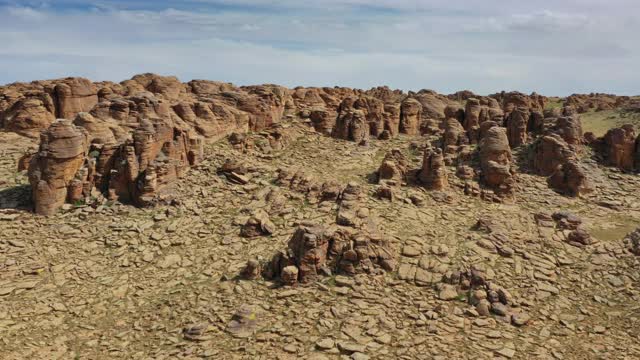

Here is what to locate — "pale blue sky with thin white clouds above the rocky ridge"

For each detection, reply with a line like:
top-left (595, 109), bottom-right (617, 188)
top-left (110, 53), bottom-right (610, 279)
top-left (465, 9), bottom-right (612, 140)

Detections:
top-left (0, 0), bottom-right (640, 96)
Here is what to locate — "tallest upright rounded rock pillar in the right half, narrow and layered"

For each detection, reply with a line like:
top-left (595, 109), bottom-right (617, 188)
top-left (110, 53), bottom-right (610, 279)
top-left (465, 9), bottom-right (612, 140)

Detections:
top-left (480, 127), bottom-right (514, 194)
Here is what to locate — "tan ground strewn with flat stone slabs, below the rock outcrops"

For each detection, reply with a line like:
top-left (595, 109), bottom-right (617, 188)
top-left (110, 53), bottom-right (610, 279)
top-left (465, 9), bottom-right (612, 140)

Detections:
top-left (0, 121), bottom-right (640, 359)
